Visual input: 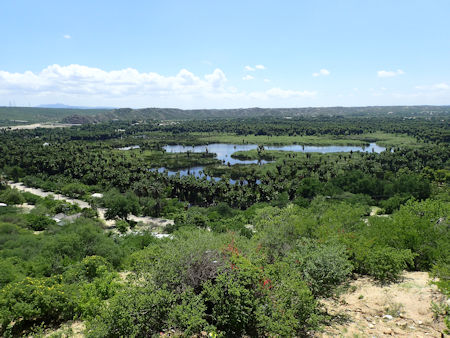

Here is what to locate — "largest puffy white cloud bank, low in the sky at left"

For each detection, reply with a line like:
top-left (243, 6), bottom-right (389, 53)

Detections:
top-left (0, 64), bottom-right (227, 96)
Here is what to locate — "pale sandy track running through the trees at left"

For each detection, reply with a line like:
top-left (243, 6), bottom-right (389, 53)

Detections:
top-left (8, 182), bottom-right (173, 227)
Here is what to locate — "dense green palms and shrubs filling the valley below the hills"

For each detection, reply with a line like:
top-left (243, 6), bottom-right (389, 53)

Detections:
top-left (0, 111), bottom-right (450, 337)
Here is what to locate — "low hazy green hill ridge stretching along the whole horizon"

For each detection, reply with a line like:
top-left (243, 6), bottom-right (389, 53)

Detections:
top-left (0, 106), bottom-right (450, 125)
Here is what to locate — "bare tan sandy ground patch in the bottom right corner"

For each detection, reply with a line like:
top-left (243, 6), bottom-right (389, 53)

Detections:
top-left (318, 272), bottom-right (446, 337)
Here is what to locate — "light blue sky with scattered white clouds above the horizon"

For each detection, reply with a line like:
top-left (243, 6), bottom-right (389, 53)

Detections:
top-left (0, 0), bottom-right (450, 108)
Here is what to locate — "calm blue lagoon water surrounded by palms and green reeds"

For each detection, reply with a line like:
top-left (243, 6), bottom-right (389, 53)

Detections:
top-left (156, 143), bottom-right (386, 184)
